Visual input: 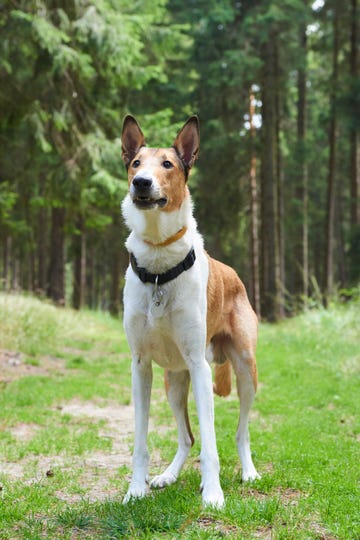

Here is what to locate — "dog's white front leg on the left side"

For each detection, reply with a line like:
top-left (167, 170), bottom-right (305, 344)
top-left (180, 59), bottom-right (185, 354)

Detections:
top-left (123, 355), bottom-right (152, 503)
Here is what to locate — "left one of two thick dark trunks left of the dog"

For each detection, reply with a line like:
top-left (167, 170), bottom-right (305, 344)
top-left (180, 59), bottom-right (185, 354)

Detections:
top-left (47, 208), bottom-right (65, 305)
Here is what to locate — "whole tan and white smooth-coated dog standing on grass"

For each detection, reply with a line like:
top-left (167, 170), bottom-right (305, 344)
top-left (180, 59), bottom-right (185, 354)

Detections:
top-left (122, 115), bottom-right (259, 507)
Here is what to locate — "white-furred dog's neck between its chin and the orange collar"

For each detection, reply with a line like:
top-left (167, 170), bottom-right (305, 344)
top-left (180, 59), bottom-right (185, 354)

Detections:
top-left (122, 195), bottom-right (194, 247)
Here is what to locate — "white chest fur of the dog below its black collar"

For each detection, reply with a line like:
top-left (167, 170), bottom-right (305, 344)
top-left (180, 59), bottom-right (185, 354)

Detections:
top-left (124, 245), bottom-right (208, 370)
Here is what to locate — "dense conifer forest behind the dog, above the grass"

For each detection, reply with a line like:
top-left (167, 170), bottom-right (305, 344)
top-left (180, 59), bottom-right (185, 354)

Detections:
top-left (0, 0), bottom-right (360, 320)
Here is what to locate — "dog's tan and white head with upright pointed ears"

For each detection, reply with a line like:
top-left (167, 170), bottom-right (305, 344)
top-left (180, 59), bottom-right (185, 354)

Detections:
top-left (121, 115), bottom-right (200, 212)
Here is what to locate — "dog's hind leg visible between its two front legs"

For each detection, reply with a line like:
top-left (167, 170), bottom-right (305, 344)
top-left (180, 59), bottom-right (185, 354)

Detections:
top-left (150, 370), bottom-right (194, 488)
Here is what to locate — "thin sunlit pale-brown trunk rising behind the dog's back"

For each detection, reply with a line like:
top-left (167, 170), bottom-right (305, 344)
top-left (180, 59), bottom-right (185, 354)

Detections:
top-left (250, 91), bottom-right (261, 317)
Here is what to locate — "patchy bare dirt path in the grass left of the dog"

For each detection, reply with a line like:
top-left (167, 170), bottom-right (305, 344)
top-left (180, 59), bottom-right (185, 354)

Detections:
top-left (0, 350), bottom-right (160, 502)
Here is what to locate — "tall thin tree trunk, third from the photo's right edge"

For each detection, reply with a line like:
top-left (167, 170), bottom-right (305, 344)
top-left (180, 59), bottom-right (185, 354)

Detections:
top-left (294, 23), bottom-right (309, 304)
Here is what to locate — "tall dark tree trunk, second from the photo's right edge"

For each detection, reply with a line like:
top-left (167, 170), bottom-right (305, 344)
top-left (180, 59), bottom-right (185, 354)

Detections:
top-left (324, 2), bottom-right (339, 306)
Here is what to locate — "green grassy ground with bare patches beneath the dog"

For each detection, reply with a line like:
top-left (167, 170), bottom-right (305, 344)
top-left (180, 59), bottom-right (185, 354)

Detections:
top-left (0, 295), bottom-right (360, 539)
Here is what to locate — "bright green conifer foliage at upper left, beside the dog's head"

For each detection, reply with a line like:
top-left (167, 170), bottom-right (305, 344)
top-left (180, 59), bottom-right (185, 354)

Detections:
top-left (0, 0), bottom-right (186, 262)
